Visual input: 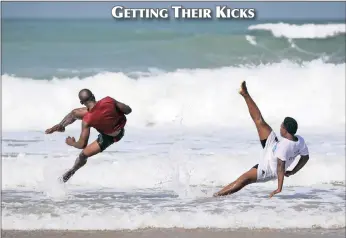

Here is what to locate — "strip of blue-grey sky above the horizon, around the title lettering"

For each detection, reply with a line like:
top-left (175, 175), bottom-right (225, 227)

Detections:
top-left (1, 2), bottom-right (346, 20)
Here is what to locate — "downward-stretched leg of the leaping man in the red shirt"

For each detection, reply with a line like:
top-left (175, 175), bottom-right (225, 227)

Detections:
top-left (62, 141), bottom-right (101, 183)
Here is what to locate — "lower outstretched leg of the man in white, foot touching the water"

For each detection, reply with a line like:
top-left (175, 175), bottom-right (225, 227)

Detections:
top-left (214, 168), bottom-right (257, 197)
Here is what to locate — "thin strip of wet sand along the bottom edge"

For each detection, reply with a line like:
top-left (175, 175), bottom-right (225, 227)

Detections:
top-left (2, 228), bottom-right (345, 238)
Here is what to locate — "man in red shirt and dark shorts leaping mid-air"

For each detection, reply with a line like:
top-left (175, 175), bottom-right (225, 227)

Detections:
top-left (45, 89), bottom-right (132, 182)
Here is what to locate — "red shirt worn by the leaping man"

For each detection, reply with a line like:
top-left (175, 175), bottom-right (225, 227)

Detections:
top-left (83, 97), bottom-right (126, 134)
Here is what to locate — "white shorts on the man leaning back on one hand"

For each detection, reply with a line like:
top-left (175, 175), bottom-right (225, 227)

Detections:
top-left (257, 131), bottom-right (278, 183)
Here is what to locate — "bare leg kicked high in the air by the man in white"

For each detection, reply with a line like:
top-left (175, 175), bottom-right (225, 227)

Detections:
top-left (239, 81), bottom-right (272, 143)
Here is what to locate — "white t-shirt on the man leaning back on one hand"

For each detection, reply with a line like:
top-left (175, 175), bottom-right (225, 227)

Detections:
top-left (270, 135), bottom-right (309, 173)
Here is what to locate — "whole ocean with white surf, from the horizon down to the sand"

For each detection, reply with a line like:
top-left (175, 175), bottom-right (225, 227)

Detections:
top-left (2, 20), bottom-right (346, 230)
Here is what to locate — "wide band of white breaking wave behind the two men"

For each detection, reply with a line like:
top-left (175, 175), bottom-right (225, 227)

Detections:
top-left (2, 61), bottom-right (345, 131)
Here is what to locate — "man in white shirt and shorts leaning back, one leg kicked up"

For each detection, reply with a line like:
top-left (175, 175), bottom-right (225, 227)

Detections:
top-left (214, 81), bottom-right (309, 197)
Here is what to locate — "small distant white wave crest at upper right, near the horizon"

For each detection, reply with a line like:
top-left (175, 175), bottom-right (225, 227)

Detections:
top-left (248, 22), bottom-right (346, 39)
